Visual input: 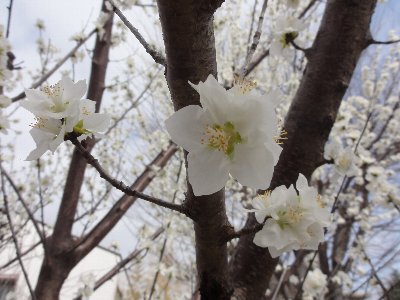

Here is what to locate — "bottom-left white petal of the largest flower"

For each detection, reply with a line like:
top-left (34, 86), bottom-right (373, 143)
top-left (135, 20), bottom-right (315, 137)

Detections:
top-left (187, 148), bottom-right (229, 196)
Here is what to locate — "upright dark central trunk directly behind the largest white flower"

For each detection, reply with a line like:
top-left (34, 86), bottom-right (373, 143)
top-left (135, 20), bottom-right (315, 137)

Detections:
top-left (157, 0), bottom-right (232, 299)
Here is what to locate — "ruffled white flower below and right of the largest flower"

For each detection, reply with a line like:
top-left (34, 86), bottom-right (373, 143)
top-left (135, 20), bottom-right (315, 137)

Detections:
top-left (253, 174), bottom-right (329, 257)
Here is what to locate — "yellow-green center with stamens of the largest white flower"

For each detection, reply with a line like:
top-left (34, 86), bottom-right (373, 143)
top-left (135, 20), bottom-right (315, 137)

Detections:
top-left (201, 122), bottom-right (244, 159)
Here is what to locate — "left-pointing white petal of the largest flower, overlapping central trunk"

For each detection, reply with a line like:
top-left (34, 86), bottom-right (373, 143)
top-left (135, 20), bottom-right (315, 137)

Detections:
top-left (165, 105), bottom-right (212, 152)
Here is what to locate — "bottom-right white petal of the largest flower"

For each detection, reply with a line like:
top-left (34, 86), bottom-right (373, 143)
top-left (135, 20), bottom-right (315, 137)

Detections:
top-left (230, 144), bottom-right (274, 189)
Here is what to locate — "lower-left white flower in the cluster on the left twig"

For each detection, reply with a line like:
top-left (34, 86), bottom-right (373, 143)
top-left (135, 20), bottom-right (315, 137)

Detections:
top-left (26, 117), bottom-right (65, 160)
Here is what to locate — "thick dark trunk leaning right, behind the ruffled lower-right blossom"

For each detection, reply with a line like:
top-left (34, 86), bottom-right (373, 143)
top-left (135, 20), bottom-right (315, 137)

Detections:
top-left (230, 0), bottom-right (376, 299)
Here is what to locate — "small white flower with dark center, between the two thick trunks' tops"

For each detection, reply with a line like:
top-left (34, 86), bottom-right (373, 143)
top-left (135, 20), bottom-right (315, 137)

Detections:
top-left (270, 16), bottom-right (305, 60)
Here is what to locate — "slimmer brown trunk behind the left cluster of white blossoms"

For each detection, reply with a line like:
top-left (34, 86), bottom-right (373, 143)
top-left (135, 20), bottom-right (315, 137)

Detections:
top-left (35, 2), bottom-right (112, 300)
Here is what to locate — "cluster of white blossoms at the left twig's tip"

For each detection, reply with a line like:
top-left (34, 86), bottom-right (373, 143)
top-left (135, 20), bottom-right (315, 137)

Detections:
top-left (21, 77), bottom-right (110, 160)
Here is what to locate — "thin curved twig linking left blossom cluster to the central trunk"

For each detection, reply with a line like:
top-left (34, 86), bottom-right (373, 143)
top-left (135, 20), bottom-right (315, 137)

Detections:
top-left (70, 137), bottom-right (189, 216)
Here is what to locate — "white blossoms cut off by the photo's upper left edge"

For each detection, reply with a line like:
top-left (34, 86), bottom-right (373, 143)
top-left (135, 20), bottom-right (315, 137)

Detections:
top-left (0, 25), bottom-right (12, 133)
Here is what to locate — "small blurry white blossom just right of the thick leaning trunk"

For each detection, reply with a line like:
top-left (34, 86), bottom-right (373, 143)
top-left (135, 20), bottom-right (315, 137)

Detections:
top-left (324, 140), bottom-right (357, 177)
